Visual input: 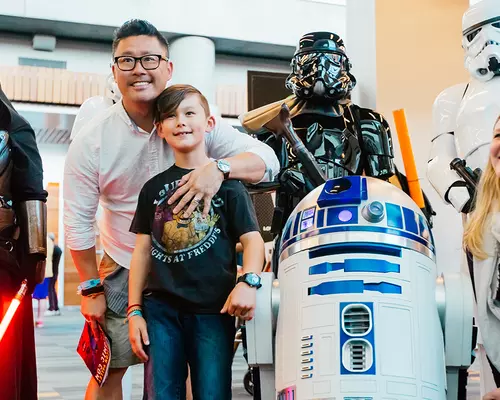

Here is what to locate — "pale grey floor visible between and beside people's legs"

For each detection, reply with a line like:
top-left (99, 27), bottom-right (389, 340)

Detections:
top-left (36, 308), bottom-right (480, 400)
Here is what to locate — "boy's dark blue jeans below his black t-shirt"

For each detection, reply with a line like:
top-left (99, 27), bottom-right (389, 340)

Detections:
top-left (144, 296), bottom-right (236, 400)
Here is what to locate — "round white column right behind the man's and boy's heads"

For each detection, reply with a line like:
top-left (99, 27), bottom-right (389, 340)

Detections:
top-left (170, 36), bottom-right (215, 107)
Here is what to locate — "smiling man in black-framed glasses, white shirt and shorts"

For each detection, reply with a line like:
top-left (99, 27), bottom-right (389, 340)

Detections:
top-left (64, 20), bottom-right (279, 400)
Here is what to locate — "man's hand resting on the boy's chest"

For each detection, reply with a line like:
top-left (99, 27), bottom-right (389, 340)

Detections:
top-left (168, 162), bottom-right (224, 218)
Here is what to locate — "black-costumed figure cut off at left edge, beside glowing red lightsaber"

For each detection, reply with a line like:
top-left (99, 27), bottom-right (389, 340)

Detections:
top-left (0, 87), bottom-right (47, 400)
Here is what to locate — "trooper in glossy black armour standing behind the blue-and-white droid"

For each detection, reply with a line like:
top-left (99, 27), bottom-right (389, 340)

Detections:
top-left (241, 32), bottom-right (414, 238)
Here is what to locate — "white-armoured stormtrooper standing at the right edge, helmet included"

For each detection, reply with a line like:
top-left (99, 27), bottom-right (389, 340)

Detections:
top-left (427, 0), bottom-right (500, 212)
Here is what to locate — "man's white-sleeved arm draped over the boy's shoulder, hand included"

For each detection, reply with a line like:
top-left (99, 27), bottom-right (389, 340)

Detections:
top-left (168, 118), bottom-right (279, 216)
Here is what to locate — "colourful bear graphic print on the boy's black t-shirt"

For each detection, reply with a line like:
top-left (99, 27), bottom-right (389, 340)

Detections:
top-left (151, 180), bottom-right (221, 263)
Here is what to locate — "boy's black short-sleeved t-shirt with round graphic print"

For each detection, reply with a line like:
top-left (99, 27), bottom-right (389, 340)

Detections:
top-left (130, 165), bottom-right (259, 313)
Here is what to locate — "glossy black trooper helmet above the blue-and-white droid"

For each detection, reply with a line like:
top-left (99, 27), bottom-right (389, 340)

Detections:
top-left (286, 32), bottom-right (356, 100)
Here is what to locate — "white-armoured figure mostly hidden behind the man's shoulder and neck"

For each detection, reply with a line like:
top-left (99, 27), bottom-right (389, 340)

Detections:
top-left (70, 74), bottom-right (122, 140)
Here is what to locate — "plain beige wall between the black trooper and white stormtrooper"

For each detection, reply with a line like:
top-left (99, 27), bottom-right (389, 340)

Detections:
top-left (375, 0), bottom-right (469, 270)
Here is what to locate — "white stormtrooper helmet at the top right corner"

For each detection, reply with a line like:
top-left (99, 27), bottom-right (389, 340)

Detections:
top-left (462, 0), bottom-right (500, 82)
